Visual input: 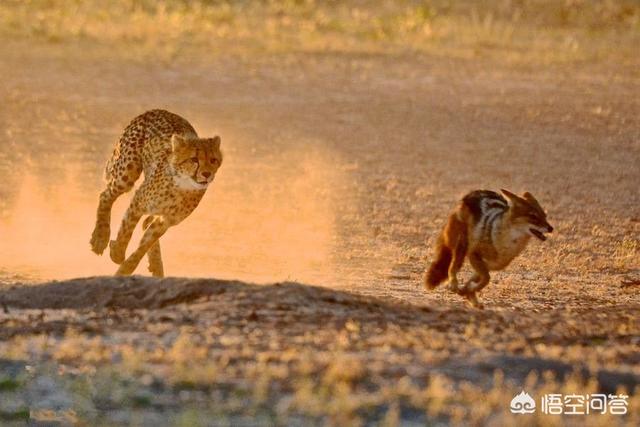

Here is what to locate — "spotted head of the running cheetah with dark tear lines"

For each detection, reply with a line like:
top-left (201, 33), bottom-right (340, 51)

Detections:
top-left (169, 134), bottom-right (222, 190)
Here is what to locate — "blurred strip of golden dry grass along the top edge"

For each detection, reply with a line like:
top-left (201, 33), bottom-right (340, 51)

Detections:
top-left (0, 0), bottom-right (640, 63)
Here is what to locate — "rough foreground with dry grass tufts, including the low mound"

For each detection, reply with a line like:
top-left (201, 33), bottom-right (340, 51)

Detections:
top-left (0, 279), bottom-right (640, 426)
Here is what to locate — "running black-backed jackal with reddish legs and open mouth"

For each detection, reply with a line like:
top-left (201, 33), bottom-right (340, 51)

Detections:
top-left (424, 190), bottom-right (553, 308)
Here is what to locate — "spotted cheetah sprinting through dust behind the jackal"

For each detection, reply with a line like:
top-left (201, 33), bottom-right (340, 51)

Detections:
top-left (90, 110), bottom-right (222, 277)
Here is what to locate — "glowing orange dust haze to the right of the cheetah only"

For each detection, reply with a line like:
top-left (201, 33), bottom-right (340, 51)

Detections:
top-left (164, 145), bottom-right (342, 283)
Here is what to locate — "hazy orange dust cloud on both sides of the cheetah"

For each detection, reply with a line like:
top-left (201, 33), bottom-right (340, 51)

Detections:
top-left (0, 145), bottom-right (344, 283)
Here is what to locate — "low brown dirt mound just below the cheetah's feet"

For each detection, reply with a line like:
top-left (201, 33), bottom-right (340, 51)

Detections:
top-left (0, 276), bottom-right (429, 312)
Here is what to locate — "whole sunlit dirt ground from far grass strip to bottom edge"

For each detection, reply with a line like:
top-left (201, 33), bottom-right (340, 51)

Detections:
top-left (0, 35), bottom-right (640, 425)
